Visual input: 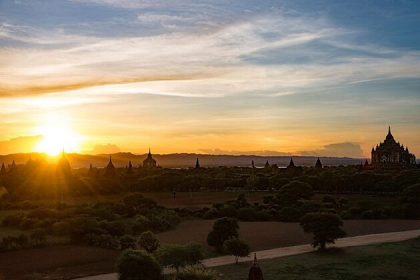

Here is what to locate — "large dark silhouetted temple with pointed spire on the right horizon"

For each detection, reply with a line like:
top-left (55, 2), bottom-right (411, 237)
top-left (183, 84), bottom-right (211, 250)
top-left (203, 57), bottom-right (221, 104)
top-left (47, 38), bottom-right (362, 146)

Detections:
top-left (371, 127), bottom-right (416, 168)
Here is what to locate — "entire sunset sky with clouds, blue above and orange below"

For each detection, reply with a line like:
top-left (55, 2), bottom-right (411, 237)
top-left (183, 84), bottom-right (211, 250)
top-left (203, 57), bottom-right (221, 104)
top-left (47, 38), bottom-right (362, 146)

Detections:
top-left (0, 0), bottom-right (420, 157)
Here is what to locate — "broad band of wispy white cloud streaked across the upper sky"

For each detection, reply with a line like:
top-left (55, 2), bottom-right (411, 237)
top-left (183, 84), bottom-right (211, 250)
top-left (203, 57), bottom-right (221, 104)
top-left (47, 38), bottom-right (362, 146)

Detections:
top-left (0, 13), bottom-right (420, 100)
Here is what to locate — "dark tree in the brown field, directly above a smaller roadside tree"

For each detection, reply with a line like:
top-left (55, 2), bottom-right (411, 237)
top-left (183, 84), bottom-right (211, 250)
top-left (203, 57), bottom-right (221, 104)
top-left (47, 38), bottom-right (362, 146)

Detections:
top-left (207, 217), bottom-right (239, 249)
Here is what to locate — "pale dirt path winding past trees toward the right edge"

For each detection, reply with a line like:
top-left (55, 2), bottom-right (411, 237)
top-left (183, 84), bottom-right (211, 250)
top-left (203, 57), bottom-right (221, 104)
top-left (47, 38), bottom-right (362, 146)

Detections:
top-left (77, 230), bottom-right (420, 280)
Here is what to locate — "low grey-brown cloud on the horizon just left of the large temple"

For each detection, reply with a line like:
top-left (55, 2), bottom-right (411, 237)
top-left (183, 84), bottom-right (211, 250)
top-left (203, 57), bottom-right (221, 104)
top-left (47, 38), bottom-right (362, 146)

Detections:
top-left (298, 142), bottom-right (363, 158)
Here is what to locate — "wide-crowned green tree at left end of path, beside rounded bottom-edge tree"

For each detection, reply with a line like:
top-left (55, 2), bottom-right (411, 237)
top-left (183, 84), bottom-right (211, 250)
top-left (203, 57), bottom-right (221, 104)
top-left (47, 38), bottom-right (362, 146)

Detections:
top-left (155, 244), bottom-right (203, 274)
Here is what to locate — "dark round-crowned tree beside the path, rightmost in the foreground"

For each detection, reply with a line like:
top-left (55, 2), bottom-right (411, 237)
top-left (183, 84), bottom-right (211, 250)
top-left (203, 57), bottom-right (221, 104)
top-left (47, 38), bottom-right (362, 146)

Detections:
top-left (300, 212), bottom-right (346, 250)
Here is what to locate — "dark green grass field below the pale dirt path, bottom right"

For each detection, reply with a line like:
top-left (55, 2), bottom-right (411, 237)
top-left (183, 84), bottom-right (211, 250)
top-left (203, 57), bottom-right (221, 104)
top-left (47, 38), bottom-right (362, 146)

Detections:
top-left (216, 238), bottom-right (420, 280)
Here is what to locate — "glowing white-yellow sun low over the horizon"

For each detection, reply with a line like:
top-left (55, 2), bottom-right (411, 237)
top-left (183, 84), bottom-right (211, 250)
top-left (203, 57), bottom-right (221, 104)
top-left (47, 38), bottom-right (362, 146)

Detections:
top-left (36, 115), bottom-right (82, 156)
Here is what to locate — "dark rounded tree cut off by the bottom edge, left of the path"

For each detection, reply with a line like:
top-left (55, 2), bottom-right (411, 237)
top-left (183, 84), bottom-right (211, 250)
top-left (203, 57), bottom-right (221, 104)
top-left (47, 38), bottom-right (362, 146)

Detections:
top-left (117, 250), bottom-right (162, 280)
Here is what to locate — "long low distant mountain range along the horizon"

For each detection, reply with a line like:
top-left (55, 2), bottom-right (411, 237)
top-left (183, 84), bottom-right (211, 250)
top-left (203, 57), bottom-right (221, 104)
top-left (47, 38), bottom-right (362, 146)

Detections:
top-left (0, 153), bottom-right (366, 168)
